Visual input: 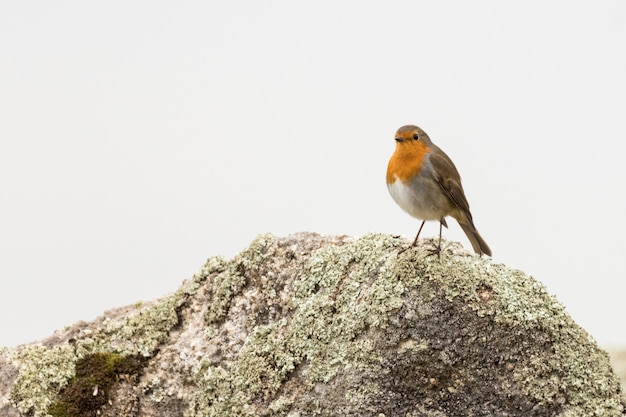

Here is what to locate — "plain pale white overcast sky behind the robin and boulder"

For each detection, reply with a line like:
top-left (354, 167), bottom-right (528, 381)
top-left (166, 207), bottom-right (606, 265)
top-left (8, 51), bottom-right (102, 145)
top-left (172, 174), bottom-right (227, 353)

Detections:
top-left (0, 0), bottom-right (626, 346)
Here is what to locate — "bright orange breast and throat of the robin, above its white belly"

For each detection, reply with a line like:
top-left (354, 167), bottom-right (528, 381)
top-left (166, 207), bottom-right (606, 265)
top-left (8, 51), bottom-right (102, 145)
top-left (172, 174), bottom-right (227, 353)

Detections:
top-left (387, 140), bottom-right (430, 184)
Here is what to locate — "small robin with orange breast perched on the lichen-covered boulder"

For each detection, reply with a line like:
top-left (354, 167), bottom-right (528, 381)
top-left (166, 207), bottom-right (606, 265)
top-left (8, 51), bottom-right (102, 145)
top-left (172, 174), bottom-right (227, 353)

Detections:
top-left (387, 125), bottom-right (491, 256)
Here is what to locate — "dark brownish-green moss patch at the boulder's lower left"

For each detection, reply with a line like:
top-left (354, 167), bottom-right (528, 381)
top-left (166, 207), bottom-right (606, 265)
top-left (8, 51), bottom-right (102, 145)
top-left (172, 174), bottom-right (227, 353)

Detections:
top-left (48, 352), bottom-right (145, 417)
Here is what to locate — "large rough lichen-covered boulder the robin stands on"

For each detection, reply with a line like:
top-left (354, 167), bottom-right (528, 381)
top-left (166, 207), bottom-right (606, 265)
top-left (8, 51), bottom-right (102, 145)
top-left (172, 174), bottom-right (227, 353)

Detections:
top-left (0, 233), bottom-right (625, 417)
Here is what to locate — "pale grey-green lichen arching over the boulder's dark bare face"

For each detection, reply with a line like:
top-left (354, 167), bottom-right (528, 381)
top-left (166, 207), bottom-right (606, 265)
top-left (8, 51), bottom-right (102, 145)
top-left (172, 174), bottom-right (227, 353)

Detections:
top-left (187, 235), bottom-right (622, 416)
